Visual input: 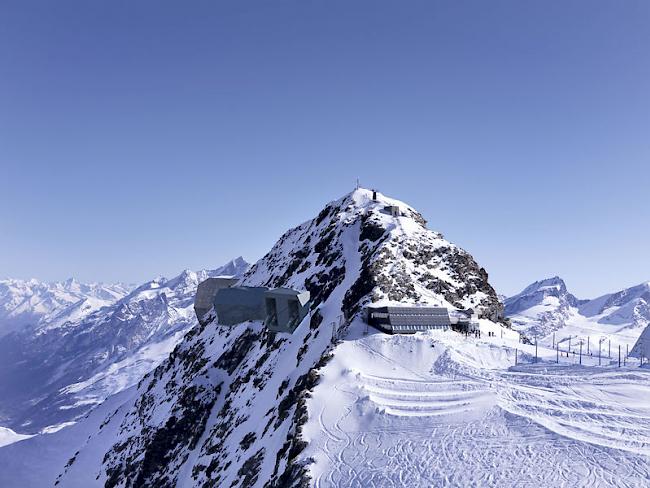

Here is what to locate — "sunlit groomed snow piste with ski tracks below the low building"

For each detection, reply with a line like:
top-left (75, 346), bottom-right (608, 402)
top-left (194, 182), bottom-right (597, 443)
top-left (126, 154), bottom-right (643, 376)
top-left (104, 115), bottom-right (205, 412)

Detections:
top-left (303, 322), bottom-right (650, 488)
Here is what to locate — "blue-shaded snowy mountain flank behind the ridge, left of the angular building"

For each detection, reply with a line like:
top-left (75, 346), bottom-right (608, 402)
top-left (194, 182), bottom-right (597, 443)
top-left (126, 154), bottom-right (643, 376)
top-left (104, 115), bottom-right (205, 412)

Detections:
top-left (0, 258), bottom-right (249, 434)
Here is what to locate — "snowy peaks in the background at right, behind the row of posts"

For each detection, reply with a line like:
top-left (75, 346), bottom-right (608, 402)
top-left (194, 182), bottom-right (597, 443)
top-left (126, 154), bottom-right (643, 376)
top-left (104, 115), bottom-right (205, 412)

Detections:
top-left (504, 276), bottom-right (650, 347)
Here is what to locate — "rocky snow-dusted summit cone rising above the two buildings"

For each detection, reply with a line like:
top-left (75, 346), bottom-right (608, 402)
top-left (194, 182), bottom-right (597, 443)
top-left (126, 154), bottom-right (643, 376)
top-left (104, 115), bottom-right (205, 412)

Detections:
top-left (243, 188), bottom-right (501, 317)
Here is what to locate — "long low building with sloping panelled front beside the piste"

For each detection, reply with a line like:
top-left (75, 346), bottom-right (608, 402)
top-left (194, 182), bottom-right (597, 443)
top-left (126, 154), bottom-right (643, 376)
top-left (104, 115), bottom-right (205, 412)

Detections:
top-left (366, 305), bottom-right (452, 334)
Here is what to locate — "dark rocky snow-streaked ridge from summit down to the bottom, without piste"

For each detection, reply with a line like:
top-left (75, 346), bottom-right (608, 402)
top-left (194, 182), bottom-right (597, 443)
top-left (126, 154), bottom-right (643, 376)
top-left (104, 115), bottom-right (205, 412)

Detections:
top-left (54, 190), bottom-right (501, 487)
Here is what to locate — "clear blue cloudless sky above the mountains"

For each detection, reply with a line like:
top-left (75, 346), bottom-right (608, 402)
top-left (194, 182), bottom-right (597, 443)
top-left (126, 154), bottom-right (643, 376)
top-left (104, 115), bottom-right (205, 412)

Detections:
top-left (0, 0), bottom-right (650, 297)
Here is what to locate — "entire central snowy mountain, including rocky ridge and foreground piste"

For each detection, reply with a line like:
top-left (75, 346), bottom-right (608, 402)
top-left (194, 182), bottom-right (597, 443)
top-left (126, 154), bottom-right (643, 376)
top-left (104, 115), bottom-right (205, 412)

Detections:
top-left (0, 190), bottom-right (650, 488)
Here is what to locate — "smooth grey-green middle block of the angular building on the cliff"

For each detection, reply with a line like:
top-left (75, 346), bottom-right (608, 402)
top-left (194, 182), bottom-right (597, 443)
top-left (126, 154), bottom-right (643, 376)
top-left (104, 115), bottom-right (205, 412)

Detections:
top-left (214, 286), bottom-right (268, 326)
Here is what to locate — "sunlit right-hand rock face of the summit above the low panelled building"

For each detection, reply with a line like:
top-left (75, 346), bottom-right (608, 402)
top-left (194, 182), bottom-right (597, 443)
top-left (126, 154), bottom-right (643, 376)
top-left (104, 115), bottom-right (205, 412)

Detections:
top-left (344, 193), bottom-right (503, 318)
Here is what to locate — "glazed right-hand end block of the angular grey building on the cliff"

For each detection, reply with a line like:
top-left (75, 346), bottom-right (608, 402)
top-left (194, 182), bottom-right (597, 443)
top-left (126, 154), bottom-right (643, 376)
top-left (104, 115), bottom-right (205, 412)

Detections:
top-left (264, 288), bottom-right (309, 333)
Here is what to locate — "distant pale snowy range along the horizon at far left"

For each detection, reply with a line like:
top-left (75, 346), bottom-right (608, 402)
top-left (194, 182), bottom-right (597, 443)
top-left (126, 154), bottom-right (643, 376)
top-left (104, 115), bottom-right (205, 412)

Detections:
top-left (0, 278), bottom-right (133, 337)
